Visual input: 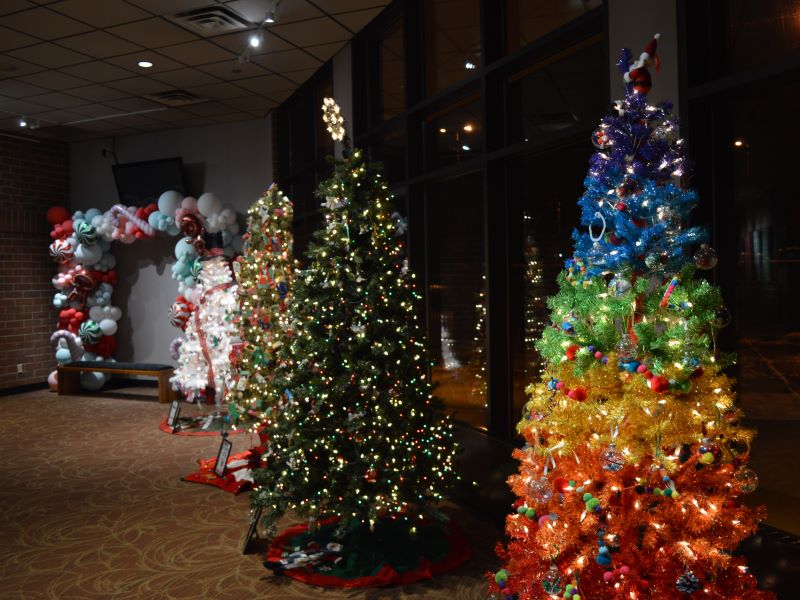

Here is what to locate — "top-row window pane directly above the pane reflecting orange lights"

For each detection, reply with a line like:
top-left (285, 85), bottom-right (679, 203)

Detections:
top-left (425, 0), bottom-right (481, 95)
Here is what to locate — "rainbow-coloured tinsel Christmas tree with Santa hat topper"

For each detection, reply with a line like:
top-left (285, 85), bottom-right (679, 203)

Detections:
top-left (490, 39), bottom-right (771, 600)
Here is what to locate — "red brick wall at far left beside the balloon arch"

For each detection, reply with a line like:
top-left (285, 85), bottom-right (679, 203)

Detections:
top-left (0, 135), bottom-right (69, 389)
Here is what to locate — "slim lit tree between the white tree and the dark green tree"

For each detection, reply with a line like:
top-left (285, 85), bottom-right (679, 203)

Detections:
top-left (228, 184), bottom-right (293, 429)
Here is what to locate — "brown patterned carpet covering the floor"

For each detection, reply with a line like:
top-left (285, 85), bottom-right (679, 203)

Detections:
top-left (0, 388), bottom-right (501, 600)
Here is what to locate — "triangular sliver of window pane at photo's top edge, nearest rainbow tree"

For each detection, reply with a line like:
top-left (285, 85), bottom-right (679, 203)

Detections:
top-left (506, 0), bottom-right (603, 53)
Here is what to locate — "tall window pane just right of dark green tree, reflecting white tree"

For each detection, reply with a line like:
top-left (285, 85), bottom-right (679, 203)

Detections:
top-left (426, 173), bottom-right (487, 429)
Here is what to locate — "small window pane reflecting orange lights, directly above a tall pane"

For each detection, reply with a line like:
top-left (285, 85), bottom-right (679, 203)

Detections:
top-left (424, 94), bottom-right (485, 170)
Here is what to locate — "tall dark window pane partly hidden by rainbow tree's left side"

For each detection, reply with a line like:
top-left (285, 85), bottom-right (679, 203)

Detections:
top-left (509, 144), bottom-right (593, 418)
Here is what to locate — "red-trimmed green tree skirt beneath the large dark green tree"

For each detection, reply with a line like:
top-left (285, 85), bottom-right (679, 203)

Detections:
top-left (265, 519), bottom-right (470, 588)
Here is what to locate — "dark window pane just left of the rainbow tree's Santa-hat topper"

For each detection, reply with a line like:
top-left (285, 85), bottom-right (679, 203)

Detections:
top-left (507, 42), bottom-right (607, 143)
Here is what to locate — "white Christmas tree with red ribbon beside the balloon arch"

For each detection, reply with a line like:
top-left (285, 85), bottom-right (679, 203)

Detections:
top-left (172, 234), bottom-right (238, 415)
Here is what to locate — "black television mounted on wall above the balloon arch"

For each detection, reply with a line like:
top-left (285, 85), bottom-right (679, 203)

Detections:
top-left (112, 157), bottom-right (186, 206)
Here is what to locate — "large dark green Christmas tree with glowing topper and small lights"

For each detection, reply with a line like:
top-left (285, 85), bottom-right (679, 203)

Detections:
top-left (252, 99), bottom-right (455, 585)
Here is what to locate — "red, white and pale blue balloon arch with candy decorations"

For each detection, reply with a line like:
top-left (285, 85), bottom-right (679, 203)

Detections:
top-left (47, 191), bottom-right (241, 390)
